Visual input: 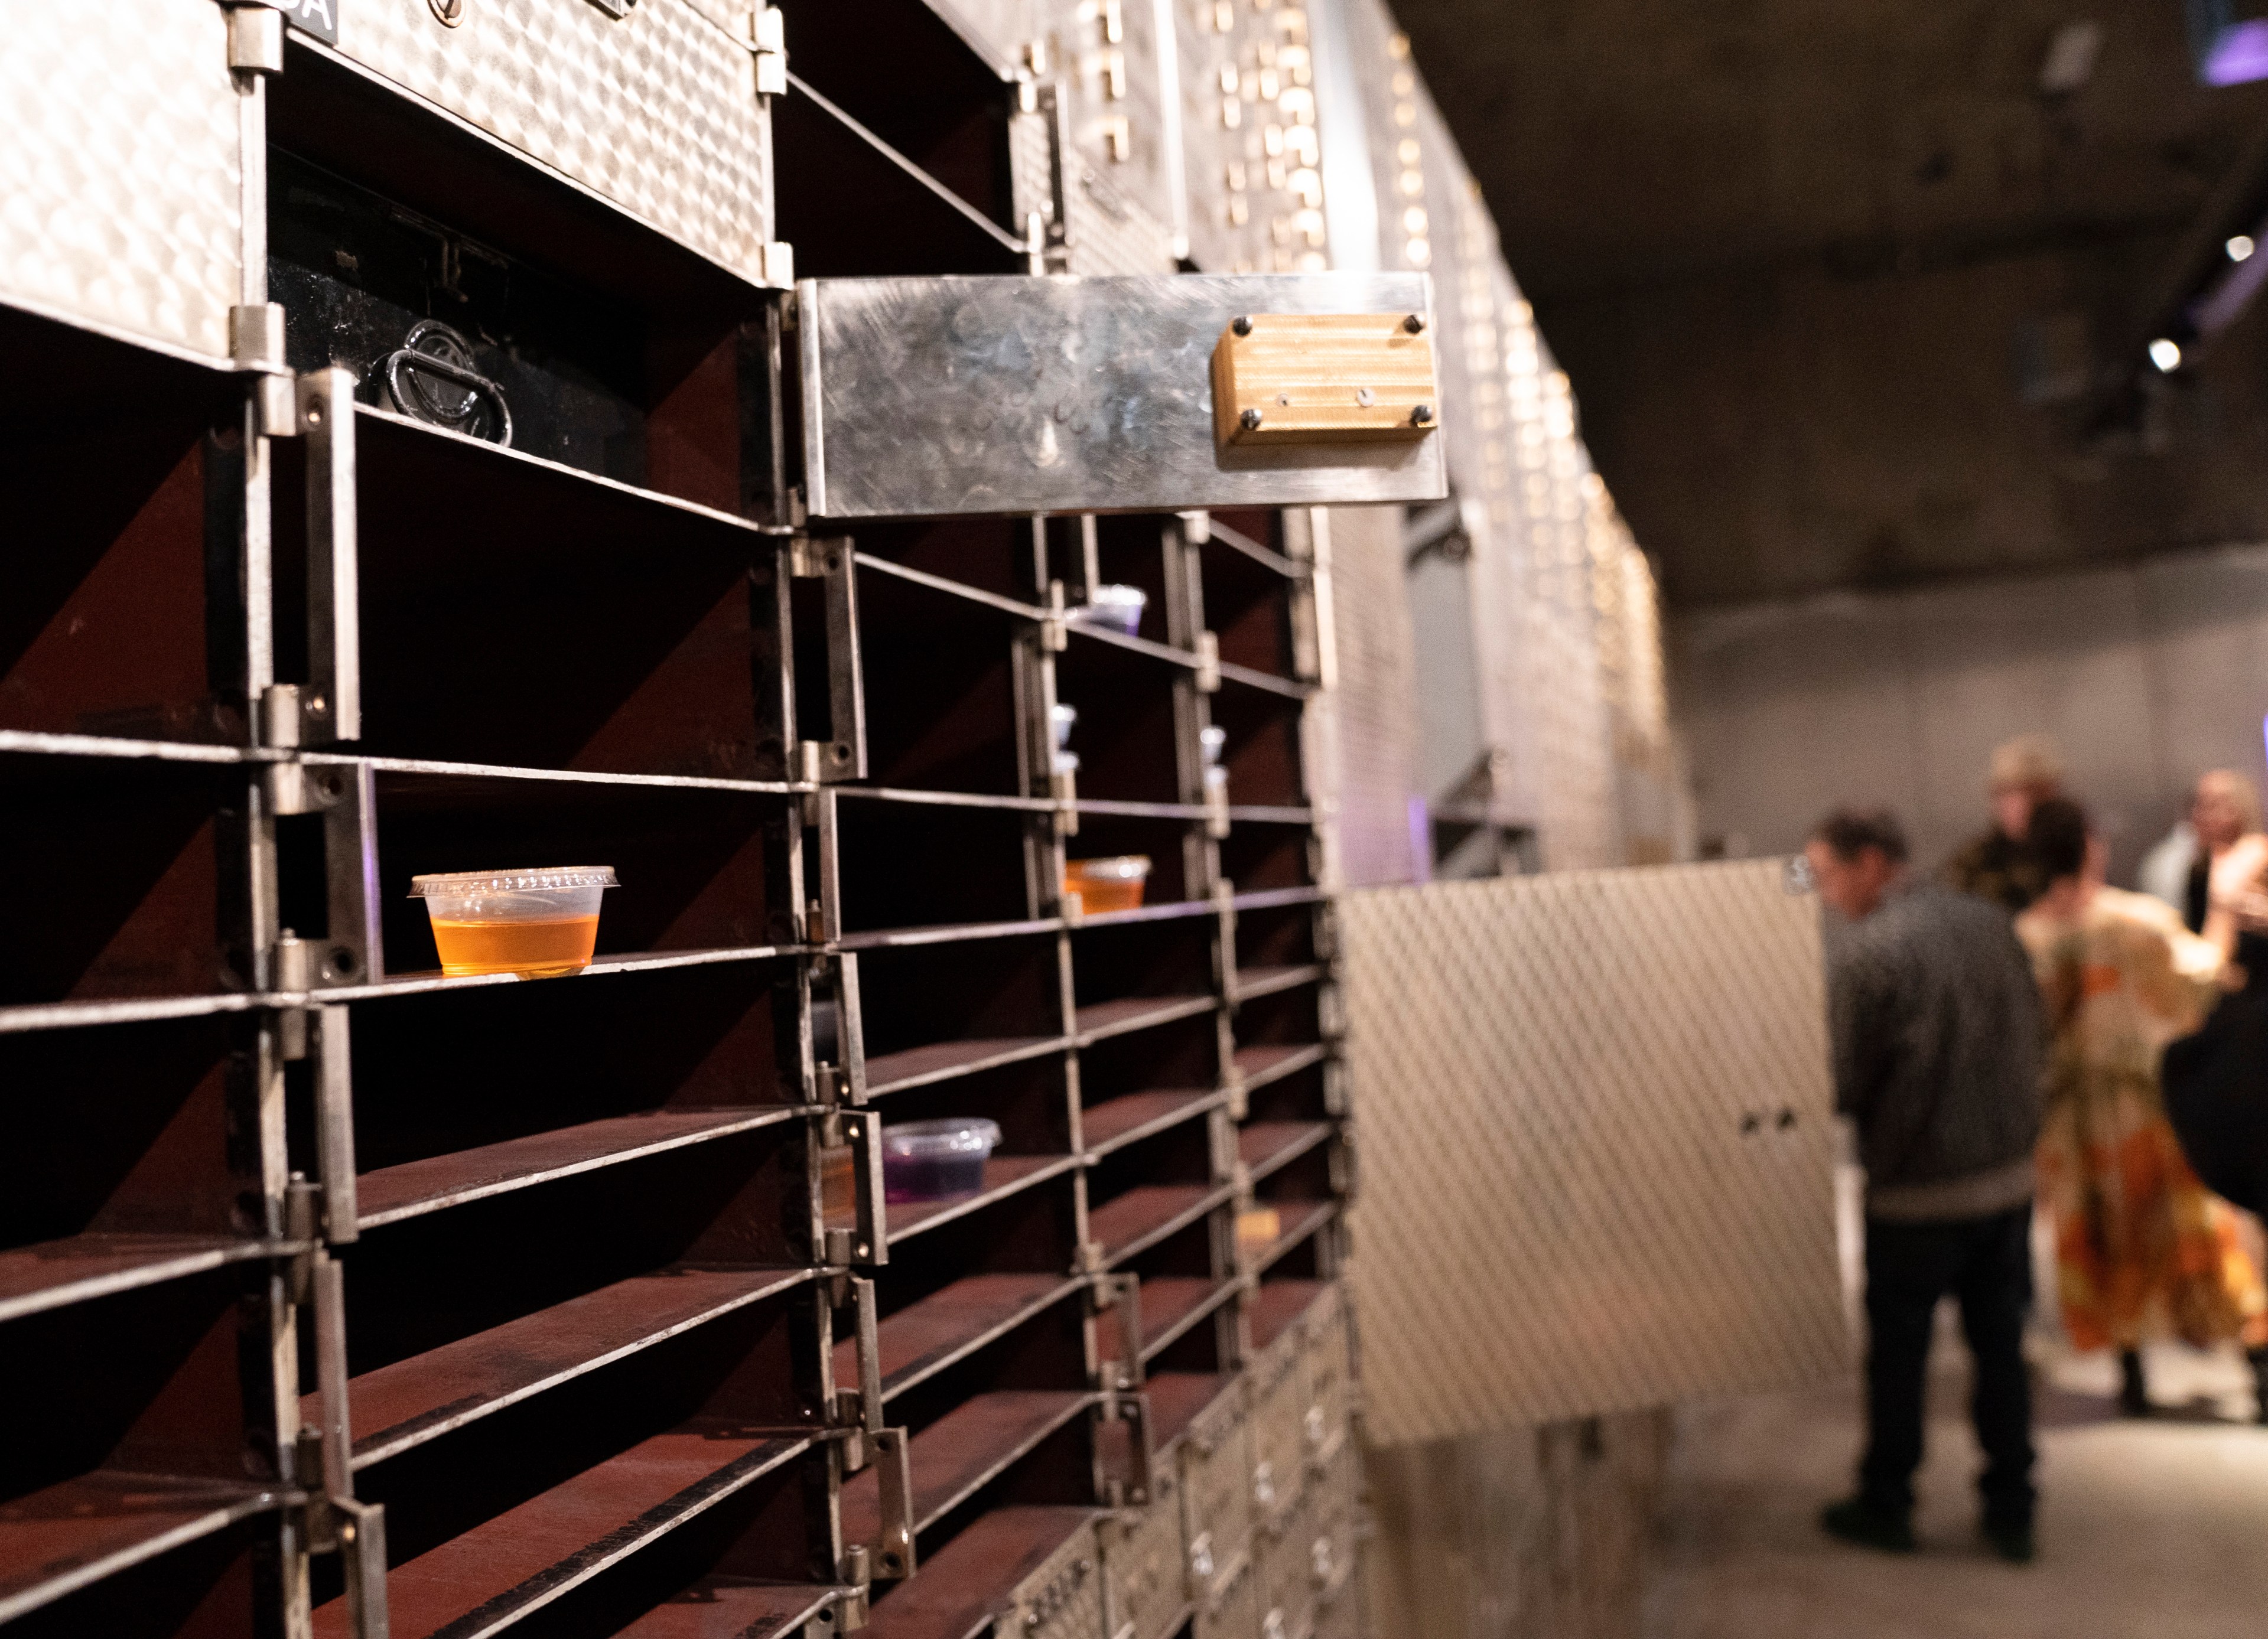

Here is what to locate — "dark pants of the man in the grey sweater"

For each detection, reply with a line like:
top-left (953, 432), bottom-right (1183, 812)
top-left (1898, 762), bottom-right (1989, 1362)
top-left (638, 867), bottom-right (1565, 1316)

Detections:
top-left (1860, 1201), bottom-right (2035, 1526)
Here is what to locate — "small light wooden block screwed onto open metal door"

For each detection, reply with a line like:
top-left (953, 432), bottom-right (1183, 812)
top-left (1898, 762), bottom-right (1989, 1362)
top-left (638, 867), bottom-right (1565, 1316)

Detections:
top-left (1213, 313), bottom-right (1440, 449)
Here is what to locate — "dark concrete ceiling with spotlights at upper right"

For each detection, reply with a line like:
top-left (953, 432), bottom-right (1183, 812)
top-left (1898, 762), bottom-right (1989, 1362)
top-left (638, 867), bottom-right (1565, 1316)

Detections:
top-left (1397, 0), bottom-right (2268, 605)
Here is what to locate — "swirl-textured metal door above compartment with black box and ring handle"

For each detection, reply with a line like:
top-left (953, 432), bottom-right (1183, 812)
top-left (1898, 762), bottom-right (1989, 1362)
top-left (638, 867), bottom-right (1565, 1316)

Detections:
top-left (322, 0), bottom-right (771, 279)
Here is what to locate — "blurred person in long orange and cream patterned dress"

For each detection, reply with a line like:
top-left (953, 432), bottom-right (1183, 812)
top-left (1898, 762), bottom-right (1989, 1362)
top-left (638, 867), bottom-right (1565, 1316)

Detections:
top-left (2016, 798), bottom-right (2268, 1417)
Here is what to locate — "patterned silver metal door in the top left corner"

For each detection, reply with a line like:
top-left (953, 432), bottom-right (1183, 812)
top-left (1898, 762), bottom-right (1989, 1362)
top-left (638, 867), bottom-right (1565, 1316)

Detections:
top-left (0, 0), bottom-right (243, 358)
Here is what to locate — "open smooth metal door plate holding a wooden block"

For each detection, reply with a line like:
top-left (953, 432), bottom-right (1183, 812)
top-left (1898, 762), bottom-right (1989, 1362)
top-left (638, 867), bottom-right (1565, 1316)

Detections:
top-left (796, 274), bottom-right (1444, 519)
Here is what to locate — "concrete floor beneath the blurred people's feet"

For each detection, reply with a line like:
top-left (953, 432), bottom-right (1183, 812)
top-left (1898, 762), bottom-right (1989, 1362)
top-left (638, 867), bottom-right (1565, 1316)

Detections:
top-left (1644, 1342), bottom-right (2268, 1639)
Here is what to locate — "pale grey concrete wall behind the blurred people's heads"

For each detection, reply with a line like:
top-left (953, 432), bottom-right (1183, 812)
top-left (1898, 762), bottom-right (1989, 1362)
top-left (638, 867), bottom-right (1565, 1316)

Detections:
top-left (1671, 546), bottom-right (2268, 879)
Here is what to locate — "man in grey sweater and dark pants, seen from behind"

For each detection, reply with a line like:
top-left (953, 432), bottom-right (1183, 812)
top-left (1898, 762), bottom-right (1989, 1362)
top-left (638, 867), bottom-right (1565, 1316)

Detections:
top-left (1805, 812), bottom-right (2046, 1562)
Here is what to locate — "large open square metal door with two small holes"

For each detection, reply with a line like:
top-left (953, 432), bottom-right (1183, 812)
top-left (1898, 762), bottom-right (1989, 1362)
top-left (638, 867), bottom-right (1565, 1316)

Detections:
top-left (1340, 862), bottom-right (1849, 1446)
